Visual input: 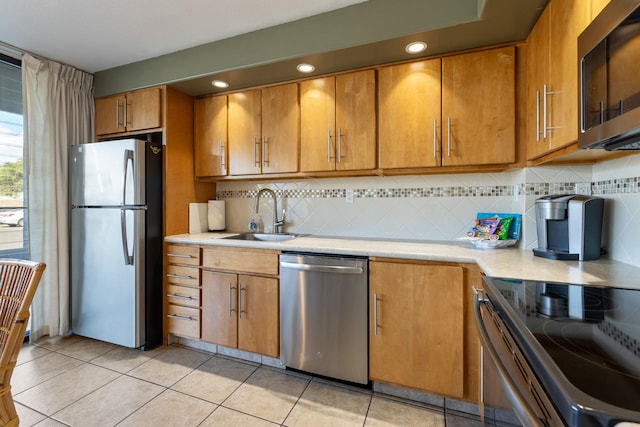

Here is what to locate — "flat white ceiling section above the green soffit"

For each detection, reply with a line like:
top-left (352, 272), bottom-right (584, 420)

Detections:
top-left (0, 0), bottom-right (366, 73)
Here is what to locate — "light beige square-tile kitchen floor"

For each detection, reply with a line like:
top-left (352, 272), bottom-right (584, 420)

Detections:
top-left (12, 336), bottom-right (492, 427)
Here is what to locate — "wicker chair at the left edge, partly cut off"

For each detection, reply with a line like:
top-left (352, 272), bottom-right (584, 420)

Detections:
top-left (0, 259), bottom-right (45, 426)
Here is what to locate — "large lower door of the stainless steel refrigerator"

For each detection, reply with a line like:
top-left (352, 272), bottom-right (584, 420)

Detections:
top-left (71, 208), bottom-right (145, 348)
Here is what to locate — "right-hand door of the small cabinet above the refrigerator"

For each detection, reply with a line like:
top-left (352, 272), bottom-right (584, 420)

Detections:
top-left (125, 88), bottom-right (162, 132)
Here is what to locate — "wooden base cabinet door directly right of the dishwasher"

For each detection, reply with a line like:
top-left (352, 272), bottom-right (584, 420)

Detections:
top-left (369, 261), bottom-right (464, 397)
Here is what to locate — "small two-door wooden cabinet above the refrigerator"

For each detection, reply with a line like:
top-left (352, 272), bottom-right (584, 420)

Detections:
top-left (95, 87), bottom-right (162, 136)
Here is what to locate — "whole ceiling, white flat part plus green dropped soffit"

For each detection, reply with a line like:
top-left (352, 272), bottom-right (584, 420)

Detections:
top-left (0, 0), bottom-right (548, 96)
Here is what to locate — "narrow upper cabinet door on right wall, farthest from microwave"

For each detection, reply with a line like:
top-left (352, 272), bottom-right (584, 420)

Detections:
top-left (525, 6), bottom-right (550, 160)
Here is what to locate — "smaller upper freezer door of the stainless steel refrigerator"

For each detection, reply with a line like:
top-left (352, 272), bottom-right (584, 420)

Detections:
top-left (69, 139), bottom-right (145, 206)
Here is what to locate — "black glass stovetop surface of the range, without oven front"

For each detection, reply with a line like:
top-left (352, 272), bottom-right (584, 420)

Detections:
top-left (485, 278), bottom-right (640, 425)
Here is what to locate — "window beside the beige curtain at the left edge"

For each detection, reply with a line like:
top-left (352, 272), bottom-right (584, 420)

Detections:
top-left (0, 54), bottom-right (29, 259)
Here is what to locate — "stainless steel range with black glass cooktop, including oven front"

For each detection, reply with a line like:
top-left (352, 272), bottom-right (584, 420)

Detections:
top-left (475, 278), bottom-right (640, 427)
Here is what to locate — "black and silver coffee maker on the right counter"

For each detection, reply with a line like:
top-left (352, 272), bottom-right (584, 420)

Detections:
top-left (533, 194), bottom-right (604, 261)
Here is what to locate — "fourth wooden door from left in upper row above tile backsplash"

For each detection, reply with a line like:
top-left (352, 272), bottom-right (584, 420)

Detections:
top-left (300, 77), bottom-right (336, 172)
